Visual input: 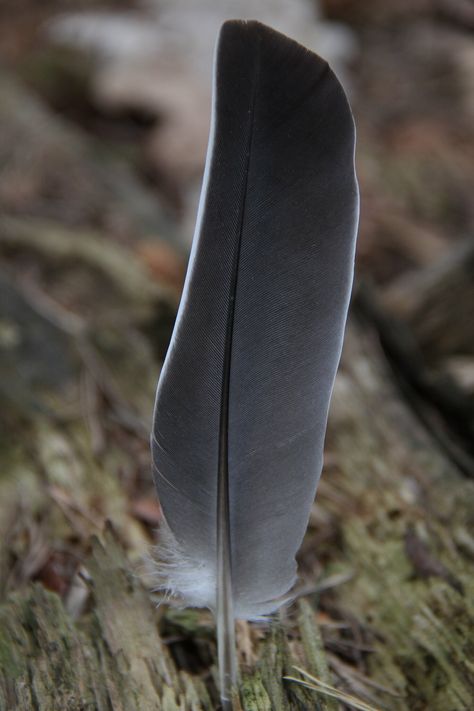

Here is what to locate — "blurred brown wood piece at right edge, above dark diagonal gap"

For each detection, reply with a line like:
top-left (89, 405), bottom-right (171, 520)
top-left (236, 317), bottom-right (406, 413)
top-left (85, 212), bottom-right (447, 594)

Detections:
top-left (368, 241), bottom-right (474, 476)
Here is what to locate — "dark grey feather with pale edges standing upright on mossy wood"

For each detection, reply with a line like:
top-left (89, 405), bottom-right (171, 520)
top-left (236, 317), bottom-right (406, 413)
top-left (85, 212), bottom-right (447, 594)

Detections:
top-left (152, 21), bottom-right (359, 708)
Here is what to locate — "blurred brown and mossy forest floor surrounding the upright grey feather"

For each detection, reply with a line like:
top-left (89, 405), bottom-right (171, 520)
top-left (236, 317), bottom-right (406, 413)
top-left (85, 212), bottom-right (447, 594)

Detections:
top-left (0, 0), bottom-right (474, 711)
